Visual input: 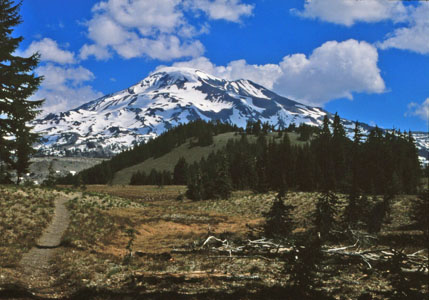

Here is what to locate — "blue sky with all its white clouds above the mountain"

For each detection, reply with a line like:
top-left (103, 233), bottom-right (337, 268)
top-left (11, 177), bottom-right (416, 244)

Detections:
top-left (14, 0), bottom-right (429, 131)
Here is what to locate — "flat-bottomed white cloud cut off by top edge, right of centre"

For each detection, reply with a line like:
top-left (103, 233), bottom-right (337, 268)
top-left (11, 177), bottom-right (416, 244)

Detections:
top-left (292, 0), bottom-right (407, 26)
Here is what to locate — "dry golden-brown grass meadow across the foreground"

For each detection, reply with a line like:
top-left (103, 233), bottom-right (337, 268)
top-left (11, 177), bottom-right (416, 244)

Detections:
top-left (0, 185), bottom-right (427, 299)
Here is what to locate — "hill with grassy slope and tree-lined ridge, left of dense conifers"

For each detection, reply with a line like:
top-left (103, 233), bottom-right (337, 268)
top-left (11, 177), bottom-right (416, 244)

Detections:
top-left (57, 120), bottom-right (318, 185)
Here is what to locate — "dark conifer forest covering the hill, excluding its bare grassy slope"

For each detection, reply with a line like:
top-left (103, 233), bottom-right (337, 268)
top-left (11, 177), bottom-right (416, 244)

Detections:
top-left (59, 115), bottom-right (422, 200)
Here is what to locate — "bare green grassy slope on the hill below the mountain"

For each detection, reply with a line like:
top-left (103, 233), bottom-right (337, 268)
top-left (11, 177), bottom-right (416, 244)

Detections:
top-left (112, 132), bottom-right (305, 184)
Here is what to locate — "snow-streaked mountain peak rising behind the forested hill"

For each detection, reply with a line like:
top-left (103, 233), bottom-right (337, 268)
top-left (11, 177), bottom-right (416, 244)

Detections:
top-left (33, 67), bottom-right (428, 163)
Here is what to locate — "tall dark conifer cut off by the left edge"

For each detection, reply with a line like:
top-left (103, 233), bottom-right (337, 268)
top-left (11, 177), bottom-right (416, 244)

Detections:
top-left (0, 0), bottom-right (43, 183)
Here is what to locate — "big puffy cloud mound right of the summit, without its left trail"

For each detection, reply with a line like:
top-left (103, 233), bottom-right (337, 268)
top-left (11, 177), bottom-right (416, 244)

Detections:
top-left (274, 40), bottom-right (385, 105)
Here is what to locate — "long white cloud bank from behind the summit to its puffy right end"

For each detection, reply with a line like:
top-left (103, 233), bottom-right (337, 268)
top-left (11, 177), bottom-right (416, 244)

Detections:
top-left (166, 39), bottom-right (385, 106)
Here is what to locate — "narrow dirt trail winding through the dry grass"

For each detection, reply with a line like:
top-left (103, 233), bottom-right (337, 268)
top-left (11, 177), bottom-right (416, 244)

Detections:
top-left (20, 194), bottom-right (76, 294)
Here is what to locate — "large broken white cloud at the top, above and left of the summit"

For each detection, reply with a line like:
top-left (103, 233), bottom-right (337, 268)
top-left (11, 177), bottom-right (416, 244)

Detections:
top-left (80, 0), bottom-right (253, 61)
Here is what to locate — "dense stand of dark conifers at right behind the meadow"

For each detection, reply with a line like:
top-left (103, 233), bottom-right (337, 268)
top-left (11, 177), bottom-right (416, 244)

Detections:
top-left (180, 115), bottom-right (421, 200)
